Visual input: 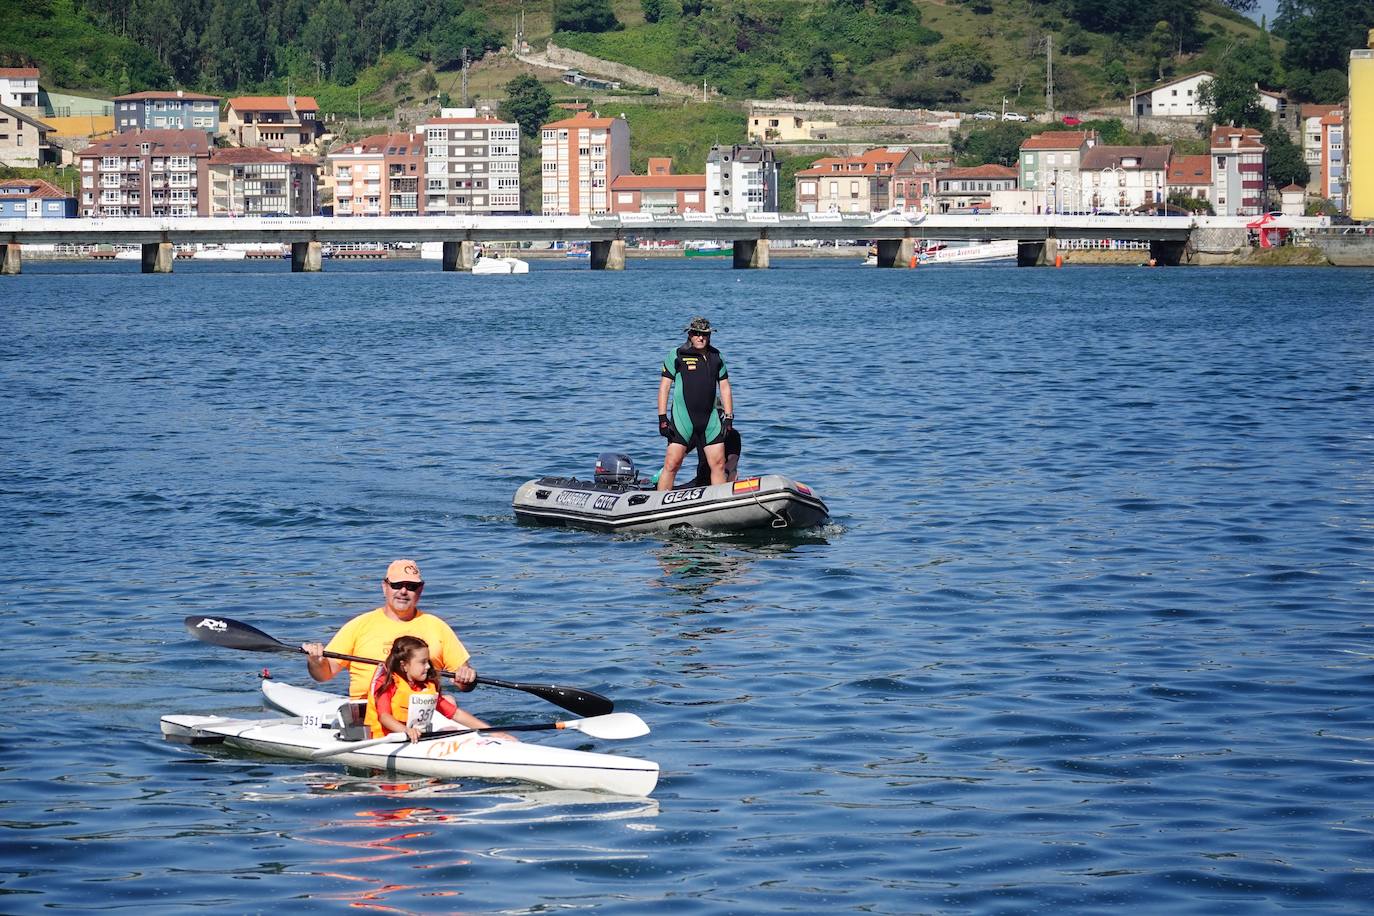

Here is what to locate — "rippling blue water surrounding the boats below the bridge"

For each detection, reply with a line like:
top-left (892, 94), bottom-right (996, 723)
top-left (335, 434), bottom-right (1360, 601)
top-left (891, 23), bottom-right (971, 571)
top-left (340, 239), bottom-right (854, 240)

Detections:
top-left (0, 260), bottom-right (1374, 915)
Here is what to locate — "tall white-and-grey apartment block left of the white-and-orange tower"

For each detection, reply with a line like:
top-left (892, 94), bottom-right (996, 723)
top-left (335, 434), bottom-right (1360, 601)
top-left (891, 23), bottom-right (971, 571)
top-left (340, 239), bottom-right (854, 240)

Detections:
top-left (419, 108), bottom-right (521, 216)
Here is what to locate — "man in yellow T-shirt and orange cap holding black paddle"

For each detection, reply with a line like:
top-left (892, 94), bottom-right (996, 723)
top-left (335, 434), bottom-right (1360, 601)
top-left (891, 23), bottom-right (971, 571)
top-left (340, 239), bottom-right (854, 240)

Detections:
top-left (301, 560), bottom-right (477, 699)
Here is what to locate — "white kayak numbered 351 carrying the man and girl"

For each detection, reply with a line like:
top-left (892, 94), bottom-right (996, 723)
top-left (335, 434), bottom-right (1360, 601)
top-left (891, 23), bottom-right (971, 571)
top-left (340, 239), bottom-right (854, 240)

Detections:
top-left (162, 680), bottom-right (658, 795)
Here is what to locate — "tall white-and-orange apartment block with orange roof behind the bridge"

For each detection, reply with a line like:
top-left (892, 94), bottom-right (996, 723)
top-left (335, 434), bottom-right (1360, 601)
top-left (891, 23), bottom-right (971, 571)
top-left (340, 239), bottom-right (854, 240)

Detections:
top-left (540, 111), bottom-right (629, 216)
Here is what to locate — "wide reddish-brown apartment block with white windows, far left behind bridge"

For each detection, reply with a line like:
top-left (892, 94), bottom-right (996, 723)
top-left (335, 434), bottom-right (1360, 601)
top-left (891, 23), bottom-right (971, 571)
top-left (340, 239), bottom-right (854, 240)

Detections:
top-left (77, 128), bottom-right (210, 217)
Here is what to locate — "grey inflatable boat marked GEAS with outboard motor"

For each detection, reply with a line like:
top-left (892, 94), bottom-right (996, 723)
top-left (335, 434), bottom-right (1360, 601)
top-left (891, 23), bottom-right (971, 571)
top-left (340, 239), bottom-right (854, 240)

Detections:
top-left (513, 452), bottom-right (830, 531)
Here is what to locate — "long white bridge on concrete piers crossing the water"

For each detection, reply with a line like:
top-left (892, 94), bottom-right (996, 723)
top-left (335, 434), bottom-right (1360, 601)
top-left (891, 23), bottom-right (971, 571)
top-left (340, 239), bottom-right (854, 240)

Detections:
top-left (0, 211), bottom-right (1316, 275)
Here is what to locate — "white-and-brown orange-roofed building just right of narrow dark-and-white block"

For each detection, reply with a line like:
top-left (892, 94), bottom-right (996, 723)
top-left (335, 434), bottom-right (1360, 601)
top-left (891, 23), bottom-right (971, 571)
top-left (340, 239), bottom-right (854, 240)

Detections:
top-left (796, 147), bottom-right (932, 213)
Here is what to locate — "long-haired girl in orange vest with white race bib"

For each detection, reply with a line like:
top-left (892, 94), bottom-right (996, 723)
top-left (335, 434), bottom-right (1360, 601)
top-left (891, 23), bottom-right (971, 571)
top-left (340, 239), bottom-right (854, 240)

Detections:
top-left (365, 636), bottom-right (488, 742)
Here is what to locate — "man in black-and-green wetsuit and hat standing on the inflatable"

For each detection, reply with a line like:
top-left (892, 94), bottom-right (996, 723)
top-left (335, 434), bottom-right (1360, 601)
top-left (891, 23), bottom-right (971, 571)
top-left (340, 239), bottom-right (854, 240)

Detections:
top-left (658, 317), bottom-right (735, 490)
